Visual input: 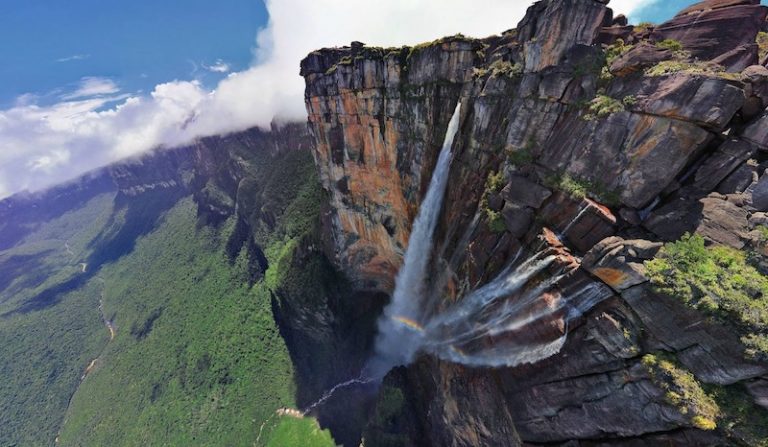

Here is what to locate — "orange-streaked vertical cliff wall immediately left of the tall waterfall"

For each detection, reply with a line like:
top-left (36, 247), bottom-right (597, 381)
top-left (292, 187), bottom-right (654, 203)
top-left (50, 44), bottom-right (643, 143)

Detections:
top-left (302, 37), bottom-right (481, 291)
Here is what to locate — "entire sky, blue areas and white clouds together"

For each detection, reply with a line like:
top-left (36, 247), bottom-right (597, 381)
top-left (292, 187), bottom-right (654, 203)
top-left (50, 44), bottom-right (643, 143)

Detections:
top-left (0, 0), bottom-right (760, 199)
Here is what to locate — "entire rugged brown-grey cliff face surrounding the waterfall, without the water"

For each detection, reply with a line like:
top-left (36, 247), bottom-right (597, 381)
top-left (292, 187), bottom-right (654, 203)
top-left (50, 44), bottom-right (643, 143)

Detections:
top-left (301, 0), bottom-right (768, 445)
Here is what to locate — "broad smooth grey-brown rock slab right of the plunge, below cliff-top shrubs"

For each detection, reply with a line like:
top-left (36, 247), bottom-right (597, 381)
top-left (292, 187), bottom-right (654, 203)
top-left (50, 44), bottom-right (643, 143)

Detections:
top-left (540, 112), bottom-right (711, 209)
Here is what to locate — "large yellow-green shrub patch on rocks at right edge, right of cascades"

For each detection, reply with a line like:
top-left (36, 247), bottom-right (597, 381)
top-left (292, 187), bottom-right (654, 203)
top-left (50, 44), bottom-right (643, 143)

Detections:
top-left (645, 234), bottom-right (768, 361)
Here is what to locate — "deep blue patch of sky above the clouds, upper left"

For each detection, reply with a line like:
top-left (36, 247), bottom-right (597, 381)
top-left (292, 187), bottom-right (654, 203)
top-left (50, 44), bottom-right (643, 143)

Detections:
top-left (0, 0), bottom-right (268, 108)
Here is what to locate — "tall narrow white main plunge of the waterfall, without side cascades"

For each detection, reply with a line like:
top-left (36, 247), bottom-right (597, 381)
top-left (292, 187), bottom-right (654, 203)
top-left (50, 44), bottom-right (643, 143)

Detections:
top-left (370, 100), bottom-right (461, 376)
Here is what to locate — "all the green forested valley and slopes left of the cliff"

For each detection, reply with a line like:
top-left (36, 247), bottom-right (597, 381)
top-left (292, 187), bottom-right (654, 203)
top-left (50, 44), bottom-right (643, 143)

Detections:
top-left (0, 146), bottom-right (333, 447)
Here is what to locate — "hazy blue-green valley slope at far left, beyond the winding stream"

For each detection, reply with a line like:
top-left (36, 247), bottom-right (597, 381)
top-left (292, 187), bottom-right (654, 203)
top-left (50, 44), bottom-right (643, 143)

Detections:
top-left (0, 194), bottom-right (117, 446)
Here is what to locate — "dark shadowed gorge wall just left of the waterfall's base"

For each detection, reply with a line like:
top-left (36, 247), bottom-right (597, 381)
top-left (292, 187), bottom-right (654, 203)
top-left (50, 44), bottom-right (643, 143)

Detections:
top-left (272, 241), bottom-right (387, 447)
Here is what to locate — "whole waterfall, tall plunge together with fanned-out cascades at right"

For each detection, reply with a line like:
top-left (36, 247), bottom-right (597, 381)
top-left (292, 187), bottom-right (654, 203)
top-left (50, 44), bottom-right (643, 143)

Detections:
top-left (361, 103), bottom-right (611, 380)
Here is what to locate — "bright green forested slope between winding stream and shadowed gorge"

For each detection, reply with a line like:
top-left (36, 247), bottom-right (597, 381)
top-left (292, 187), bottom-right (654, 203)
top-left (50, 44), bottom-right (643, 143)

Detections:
top-left (61, 199), bottom-right (294, 445)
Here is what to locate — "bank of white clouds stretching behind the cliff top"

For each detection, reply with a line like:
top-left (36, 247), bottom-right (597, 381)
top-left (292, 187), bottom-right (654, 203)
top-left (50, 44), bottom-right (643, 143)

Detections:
top-left (0, 0), bottom-right (653, 197)
